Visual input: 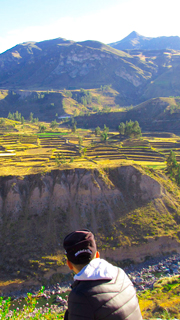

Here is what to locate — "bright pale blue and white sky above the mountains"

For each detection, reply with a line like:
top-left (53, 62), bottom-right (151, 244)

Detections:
top-left (0, 0), bottom-right (180, 53)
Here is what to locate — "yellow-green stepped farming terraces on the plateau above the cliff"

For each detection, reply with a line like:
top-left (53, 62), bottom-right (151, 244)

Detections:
top-left (0, 120), bottom-right (180, 175)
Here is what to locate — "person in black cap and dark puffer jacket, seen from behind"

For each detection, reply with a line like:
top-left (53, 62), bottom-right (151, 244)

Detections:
top-left (63, 229), bottom-right (142, 320)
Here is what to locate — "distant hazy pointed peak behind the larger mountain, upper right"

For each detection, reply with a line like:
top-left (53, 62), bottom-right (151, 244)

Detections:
top-left (109, 31), bottom-right (180, 50)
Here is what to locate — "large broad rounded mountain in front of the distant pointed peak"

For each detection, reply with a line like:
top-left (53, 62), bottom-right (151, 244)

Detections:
top-left (0, 38), bottom-right (154, 103)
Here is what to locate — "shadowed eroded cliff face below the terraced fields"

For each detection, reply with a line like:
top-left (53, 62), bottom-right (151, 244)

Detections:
top-left (0, 166), bottom-right (178, 266)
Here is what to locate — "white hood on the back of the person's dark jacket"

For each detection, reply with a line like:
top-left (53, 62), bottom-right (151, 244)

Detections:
top-left (74, 258), bottom-right (118, 281)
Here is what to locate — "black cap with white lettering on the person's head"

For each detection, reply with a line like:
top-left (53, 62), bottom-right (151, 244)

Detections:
top-left (63, 229), bottom-right (96, 264)
